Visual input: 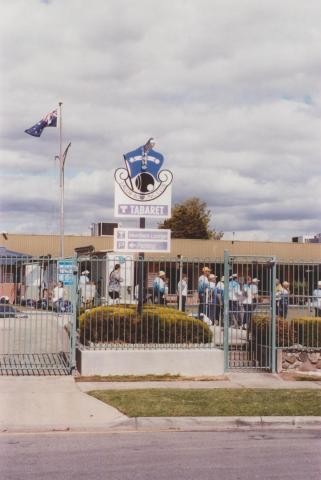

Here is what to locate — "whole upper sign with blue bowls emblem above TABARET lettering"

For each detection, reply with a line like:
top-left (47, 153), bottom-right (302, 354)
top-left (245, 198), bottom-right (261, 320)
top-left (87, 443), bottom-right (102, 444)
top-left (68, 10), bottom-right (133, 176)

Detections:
top-left (115, 138), bottom-right (173, 218)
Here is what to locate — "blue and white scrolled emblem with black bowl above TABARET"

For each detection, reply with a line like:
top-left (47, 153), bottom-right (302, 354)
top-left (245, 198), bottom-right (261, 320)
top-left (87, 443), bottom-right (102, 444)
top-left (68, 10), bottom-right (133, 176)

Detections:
top-left (115, 138), bottom-right (173, 202)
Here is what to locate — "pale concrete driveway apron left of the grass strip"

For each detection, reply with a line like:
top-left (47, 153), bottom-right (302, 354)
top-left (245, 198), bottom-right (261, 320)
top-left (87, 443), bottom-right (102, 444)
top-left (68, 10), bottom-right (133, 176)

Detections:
top-left (0, 376), bottom-right (127, 432)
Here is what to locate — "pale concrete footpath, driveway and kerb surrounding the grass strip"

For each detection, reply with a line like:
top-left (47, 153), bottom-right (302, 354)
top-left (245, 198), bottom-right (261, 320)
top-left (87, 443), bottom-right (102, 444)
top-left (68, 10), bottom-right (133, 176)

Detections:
top-left (0, 373), bottom-right (321, 433)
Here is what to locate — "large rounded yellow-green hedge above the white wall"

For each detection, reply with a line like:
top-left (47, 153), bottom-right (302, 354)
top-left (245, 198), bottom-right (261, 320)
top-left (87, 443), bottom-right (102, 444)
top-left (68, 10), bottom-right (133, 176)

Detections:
top-left (79, 305), bottom-right (212, 345)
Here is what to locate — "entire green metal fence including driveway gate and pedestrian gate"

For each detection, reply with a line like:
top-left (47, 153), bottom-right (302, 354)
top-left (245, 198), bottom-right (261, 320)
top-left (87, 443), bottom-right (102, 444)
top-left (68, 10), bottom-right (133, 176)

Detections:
top-left (0, 253), bottom-right (321, 373)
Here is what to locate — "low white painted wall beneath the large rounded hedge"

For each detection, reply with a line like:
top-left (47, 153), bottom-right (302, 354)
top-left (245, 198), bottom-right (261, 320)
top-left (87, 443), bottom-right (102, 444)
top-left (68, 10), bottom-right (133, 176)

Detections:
top-left (77, 348), bottom-right (224, 376)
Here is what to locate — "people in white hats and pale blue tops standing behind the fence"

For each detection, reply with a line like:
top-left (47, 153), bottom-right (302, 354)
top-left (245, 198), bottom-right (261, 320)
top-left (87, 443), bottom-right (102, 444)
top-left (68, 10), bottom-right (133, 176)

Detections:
top-left (93, 264), bottom-right (321, 322)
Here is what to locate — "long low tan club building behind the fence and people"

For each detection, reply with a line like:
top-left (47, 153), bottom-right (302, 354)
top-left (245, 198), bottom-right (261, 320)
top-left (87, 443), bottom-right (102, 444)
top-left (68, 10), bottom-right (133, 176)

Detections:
top-left (0, 233), bottom-right (321, 302)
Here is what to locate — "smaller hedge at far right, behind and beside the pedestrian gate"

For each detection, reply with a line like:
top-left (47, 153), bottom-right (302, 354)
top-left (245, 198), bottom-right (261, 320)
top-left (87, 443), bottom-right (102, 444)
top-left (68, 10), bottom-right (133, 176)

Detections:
top-left (252, 315), bottom-right (321, 348)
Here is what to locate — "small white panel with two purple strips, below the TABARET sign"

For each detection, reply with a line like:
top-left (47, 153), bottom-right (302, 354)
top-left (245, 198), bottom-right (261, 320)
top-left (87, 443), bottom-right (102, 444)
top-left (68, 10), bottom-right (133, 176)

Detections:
top-left (114, 228), bottom-right (171, 253)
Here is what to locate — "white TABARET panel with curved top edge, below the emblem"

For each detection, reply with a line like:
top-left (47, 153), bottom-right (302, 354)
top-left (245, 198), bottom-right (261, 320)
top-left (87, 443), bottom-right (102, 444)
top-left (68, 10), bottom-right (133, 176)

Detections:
top-left (114, 182), bottom-right (172, 218)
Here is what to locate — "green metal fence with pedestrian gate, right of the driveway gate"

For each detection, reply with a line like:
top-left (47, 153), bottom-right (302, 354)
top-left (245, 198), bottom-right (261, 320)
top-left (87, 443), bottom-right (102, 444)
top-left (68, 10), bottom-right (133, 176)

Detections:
top-left (78, 254), bottom-right (321, 358)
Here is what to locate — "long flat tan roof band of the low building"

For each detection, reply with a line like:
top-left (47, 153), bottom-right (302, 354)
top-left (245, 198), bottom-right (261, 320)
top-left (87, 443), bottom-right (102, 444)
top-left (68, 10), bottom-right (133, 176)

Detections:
top-left (2, 233), bottom-right (321, 263)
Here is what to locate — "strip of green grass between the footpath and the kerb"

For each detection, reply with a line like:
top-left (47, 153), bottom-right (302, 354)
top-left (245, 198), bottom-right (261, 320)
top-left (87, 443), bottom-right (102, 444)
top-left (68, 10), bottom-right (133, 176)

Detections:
top-left (89, 388), bottom-right (321, 417)
